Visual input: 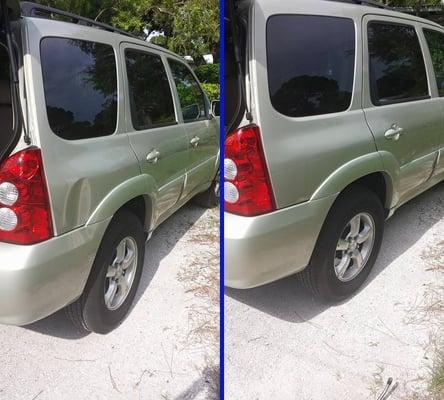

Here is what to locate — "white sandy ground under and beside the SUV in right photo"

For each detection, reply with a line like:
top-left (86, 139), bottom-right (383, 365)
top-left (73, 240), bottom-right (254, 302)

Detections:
top-left (225, 184), bottom-right (444, 400)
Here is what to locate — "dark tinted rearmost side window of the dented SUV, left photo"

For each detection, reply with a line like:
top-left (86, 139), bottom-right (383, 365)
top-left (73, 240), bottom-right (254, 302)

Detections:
top-left (41, 38), bottom-right (117, 140)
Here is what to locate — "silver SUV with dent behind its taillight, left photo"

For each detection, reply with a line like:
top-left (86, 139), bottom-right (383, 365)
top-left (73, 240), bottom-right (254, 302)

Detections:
top-left (0, 0), bottom-right (219, 333)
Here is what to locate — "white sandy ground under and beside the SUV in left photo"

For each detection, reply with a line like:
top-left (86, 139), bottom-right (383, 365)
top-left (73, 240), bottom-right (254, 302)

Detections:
top-left (0, 205), bottom-right (219, 400)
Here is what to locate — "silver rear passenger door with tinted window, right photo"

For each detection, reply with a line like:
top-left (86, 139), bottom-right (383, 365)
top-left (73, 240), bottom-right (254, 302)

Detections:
top-left (363, 15), bottom-right (442, 203)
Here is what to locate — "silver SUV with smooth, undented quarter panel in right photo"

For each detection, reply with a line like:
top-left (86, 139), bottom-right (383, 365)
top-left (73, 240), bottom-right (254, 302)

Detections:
top-left (224, 0), bottom-right (444, 302)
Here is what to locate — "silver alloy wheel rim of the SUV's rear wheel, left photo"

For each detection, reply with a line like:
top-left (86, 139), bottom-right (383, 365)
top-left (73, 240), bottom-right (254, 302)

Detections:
top-left (104, 236), bottom-right (138, 310)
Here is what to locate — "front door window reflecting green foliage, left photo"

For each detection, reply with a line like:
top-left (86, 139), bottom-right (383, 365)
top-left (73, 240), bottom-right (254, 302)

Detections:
top-left (169, 60), bottom-right (207, 122)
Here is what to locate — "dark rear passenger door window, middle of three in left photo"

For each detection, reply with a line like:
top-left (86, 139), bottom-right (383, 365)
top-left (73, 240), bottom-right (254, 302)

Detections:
top-left (125, 50), bottom-right (176, 130)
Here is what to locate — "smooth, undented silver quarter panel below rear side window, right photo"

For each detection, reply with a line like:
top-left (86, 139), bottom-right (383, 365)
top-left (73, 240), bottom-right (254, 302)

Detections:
top-left (261, 110), bottom-right (376, 208)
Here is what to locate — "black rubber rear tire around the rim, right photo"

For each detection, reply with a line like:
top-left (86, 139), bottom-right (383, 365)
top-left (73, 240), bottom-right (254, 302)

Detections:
top-left (300, 186), bottom-right (385, 303)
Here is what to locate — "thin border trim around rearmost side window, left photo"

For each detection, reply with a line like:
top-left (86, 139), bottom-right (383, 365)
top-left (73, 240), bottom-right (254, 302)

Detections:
top-left (39, 35), bottom-right (121, 142)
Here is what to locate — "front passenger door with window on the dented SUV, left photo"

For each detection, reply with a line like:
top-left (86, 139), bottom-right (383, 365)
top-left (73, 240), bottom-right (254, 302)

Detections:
top-left (168, 58), bottom-right (219, 198)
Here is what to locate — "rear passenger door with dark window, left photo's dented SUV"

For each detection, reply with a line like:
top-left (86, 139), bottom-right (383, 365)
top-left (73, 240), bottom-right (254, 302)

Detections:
top-left (122, 44), bottom-right (189, 219)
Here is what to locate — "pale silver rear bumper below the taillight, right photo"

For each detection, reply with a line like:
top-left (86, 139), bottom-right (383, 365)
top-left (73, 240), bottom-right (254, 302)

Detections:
top-left (224, 195), bottom-right (336, 289)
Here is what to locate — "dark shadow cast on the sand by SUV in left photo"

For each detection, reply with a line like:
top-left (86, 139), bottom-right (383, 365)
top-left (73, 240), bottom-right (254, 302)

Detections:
top-left (23, 203), bottom-right (206, 340)
